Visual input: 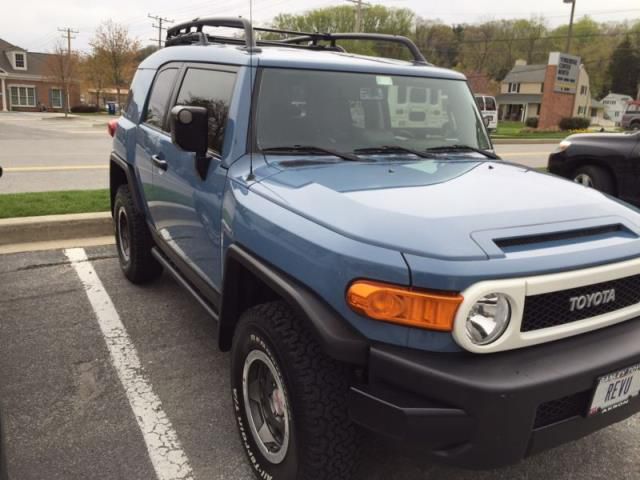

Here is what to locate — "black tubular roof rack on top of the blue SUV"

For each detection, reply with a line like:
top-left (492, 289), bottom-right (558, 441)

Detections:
top-left (165, 17), bottom-right (429, 65)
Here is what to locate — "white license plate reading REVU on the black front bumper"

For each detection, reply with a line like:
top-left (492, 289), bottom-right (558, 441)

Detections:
top-left (589, 364), bottom-right (640, 416)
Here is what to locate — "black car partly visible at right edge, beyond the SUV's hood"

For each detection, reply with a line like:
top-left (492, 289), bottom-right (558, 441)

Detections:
top-left (549, 132), bottom-right (640, 205)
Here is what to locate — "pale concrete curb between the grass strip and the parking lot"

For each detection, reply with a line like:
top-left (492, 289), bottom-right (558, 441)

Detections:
top-left (0, 212), bottom-right (113, 245)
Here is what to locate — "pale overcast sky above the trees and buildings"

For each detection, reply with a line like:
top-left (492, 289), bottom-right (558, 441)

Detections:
top-left (0, 0), bottom-right (640, 51)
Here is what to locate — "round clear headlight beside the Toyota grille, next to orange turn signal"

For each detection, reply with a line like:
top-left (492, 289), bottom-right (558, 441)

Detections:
top-left (467, 293), bottom-right (511, 345)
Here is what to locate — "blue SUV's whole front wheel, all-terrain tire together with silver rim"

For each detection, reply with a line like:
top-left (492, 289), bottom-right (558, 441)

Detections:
top-left (231, 302), bottom-right (359, 480)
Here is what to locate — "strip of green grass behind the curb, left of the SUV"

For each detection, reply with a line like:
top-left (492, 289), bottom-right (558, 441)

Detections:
top-left (0, 189), bottom-right (110, 218)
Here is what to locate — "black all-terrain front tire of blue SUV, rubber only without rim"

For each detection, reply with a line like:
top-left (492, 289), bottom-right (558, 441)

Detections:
top-left (231, 301), bottom-right (361, 480)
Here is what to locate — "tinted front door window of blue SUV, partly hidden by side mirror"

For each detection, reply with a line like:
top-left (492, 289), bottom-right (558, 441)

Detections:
top-left (176, 68), bottom-right (236, 154)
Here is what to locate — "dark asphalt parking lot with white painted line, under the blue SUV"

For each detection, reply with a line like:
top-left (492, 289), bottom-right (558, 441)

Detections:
top-left (0, 246), bottom-right (640, 480)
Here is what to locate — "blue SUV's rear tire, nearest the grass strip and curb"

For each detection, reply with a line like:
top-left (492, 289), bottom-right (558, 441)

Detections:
top-left (113, 185), bottom-right (162, 284)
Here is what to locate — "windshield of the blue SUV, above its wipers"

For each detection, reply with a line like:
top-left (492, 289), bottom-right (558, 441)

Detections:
top-left (256, 68), bottom-right (491, 152)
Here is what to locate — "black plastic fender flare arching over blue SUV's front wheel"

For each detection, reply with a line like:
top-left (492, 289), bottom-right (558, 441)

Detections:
top-left (218, 244), bottom-right (369, 366)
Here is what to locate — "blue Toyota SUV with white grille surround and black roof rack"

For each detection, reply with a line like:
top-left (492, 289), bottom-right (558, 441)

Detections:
top-left (110, 18), bottom-right (640, 480)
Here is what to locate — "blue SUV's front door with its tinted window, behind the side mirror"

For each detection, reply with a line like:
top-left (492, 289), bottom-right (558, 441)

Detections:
top-left (150, 64), bottom-right (236, 291)
